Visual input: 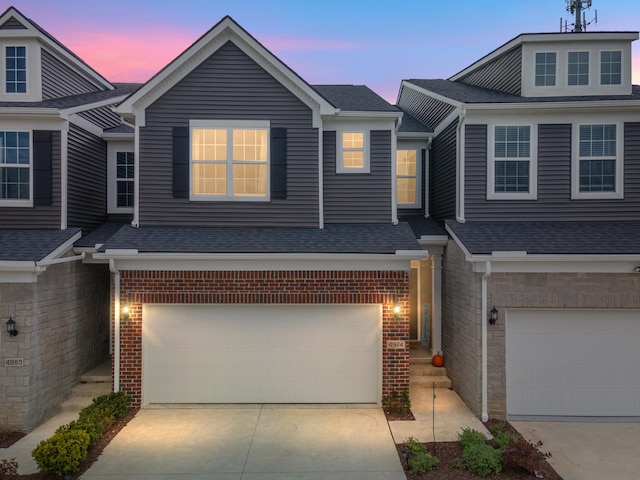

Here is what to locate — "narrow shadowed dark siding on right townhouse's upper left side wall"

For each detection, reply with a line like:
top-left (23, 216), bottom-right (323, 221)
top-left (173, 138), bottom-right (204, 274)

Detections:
top-left (428, 121), bottom-right (458, 220)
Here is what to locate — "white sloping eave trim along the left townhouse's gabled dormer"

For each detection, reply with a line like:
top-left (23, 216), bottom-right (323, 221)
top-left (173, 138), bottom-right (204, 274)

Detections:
top-left (0, 7), bottom-right (114, 90)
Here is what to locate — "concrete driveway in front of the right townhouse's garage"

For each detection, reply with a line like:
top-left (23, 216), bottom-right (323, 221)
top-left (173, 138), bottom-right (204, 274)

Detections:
top-left (511, 421), bottom-right (640, 480)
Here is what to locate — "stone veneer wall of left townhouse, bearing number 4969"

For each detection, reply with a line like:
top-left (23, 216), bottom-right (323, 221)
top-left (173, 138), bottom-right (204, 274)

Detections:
top-left (0, 261), bottom-right (110, 431)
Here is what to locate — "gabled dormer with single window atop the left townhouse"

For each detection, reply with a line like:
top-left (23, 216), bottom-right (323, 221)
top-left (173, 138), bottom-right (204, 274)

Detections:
top-left (0, 7), bottom-right (113, 102)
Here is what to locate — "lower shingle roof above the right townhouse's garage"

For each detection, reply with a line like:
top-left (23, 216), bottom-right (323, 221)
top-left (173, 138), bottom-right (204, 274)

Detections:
top-left (446, 220), bottom-right (640, 255)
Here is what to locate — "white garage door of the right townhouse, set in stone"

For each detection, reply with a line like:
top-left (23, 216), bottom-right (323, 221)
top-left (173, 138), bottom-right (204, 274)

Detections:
top-left (505, 310), bottom-right (640, 418)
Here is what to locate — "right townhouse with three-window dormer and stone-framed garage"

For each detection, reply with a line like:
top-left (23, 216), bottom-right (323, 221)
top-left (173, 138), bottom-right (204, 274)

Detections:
top-left (397, 32), bottom-right (640, 418)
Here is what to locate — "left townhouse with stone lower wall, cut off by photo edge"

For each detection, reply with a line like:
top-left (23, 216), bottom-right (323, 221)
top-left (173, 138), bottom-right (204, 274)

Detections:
top-left (0, 8), bottom-right (139, 430)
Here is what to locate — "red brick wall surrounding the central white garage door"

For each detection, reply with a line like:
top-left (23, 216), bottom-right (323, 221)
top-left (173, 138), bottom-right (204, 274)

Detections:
top-left (115, 270), bottom-right (409, 405)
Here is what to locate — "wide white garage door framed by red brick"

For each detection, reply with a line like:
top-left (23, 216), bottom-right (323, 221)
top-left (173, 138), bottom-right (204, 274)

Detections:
top-left (142, 305), bottom-right (382, 403)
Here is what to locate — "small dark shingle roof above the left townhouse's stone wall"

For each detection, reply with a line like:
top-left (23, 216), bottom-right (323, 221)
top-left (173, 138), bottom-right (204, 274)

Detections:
top-left (0, 228), bottom-right (80, 262)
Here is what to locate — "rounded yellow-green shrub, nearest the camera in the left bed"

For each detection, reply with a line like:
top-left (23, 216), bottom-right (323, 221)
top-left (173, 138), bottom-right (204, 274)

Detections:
top-left (31, 429), bottom-right (89, 477)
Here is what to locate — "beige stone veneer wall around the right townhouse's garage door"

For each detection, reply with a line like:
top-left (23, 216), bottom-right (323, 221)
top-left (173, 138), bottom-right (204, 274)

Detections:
top-left (442, 240), bottom-right (640, 418)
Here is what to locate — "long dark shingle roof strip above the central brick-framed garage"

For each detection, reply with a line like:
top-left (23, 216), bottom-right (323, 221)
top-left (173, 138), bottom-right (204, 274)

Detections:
top-left (99, 222), bottom-right (420, 254)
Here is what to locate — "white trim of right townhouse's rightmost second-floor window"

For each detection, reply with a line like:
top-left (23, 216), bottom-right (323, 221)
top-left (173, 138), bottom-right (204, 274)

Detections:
top-left (571, 124), bottom-right (624, 200)
